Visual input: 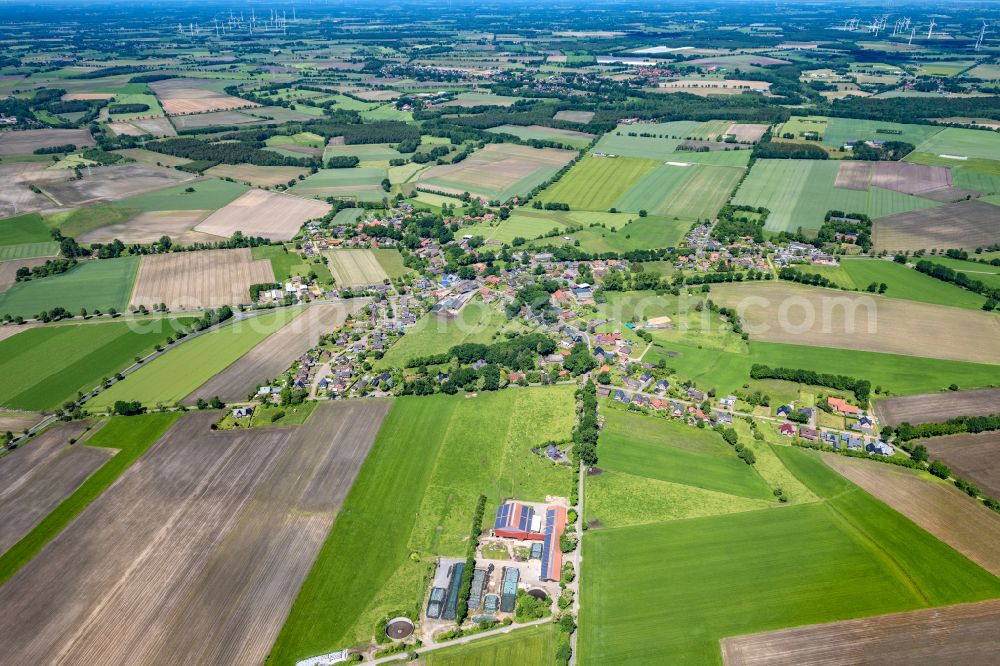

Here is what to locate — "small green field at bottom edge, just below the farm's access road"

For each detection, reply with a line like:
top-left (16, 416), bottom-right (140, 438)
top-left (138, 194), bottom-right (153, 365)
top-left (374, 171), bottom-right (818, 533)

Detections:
top-left (423, 623), bottom-right (559, 666)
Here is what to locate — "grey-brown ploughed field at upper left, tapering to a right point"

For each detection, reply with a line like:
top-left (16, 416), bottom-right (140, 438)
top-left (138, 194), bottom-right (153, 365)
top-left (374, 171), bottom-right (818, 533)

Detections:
top-left (36, 164), bottom-right (194, 207)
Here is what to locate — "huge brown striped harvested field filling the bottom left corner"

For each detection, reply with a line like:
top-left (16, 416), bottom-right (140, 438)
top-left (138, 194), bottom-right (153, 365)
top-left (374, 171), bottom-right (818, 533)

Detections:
top-left (0, 401), bottom-right (390, 664)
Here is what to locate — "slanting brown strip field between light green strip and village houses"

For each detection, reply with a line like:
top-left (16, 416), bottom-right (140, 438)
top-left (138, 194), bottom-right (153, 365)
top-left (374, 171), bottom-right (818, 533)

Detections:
top-left (183, 298), bottom-right (365, 405)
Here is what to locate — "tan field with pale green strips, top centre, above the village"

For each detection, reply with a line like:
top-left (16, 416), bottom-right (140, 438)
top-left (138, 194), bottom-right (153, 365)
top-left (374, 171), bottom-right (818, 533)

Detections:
top-left (417, 143), bottom-right (576, 201)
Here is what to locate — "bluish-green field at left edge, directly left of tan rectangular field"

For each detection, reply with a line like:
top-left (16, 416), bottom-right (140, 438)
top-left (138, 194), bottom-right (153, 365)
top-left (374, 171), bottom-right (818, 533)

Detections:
top-left (0, 256), bottom-right (139, 318)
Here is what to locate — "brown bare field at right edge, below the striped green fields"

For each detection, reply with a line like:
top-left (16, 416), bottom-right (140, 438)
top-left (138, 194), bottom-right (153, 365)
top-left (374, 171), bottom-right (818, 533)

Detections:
top-left (872, 200), bottom-right (1000, 252)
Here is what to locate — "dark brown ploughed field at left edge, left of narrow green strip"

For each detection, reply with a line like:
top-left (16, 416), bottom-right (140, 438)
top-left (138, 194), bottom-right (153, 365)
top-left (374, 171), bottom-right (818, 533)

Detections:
top-left (0, 422), bottom-right (109, 553)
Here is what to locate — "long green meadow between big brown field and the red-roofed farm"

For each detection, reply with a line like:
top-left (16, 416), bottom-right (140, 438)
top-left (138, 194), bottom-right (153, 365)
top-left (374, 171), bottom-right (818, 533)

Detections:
top-left (271, 387), bottom-right (574, 665)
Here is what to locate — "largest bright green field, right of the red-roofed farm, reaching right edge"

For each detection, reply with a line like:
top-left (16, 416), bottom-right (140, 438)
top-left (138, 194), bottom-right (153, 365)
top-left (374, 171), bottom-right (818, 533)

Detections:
top-left (578, 447), bottom-right (1000, 665)
